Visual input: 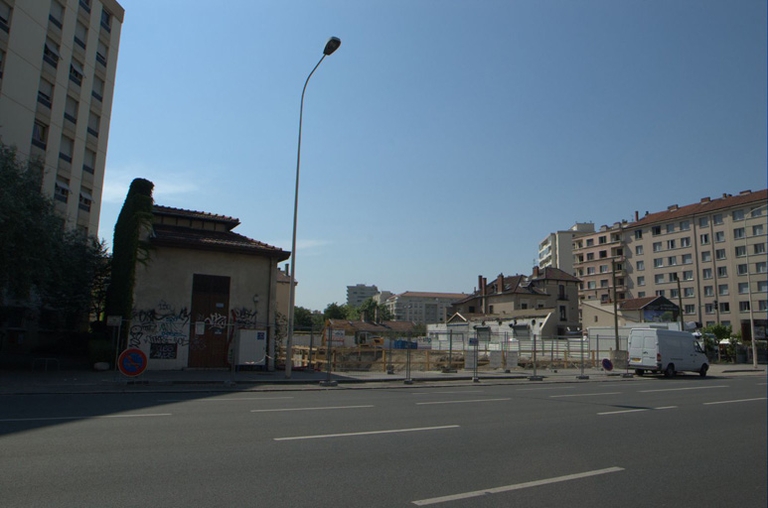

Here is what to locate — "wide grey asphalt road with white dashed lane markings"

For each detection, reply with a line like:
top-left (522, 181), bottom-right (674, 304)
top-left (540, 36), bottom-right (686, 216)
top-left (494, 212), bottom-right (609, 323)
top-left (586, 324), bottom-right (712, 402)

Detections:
top-left (0, 376), bottom-right (768, 508)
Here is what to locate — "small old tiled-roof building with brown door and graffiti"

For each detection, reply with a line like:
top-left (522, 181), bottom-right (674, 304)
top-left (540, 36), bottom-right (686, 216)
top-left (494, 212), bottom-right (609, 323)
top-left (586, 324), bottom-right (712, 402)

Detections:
top-left (129, 206), bottom-right (290, 369)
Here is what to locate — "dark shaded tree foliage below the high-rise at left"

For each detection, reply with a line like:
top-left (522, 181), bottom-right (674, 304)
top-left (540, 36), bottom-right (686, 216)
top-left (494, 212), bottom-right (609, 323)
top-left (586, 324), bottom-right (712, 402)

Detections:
top-left (0, 144), bottom-right (108, 329)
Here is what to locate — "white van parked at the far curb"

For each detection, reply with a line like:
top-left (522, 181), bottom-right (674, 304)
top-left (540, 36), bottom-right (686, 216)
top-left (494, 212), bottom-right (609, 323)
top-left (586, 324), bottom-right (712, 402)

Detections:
top-left (628, 328), bottom-right (709, 377)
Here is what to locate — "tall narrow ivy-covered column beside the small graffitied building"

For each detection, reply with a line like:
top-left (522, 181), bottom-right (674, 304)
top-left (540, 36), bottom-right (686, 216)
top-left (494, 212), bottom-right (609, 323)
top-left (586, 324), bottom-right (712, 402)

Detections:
top-left (106, 178), bottom-right (154, 346)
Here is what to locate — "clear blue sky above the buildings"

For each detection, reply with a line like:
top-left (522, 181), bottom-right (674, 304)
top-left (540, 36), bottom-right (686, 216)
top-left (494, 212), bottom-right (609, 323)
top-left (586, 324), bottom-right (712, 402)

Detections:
top-left (99, 0), bottom-right (768, 310)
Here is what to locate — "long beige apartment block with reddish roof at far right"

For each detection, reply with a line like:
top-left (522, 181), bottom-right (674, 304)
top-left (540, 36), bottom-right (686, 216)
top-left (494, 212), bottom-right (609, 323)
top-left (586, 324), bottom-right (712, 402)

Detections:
top-left (574, 190), bottom-right (768, 335)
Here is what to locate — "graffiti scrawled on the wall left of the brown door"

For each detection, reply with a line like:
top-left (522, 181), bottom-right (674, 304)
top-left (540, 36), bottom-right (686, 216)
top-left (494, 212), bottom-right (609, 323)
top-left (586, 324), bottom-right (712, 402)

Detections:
top-left (128, 300), bottom-right (190, 347)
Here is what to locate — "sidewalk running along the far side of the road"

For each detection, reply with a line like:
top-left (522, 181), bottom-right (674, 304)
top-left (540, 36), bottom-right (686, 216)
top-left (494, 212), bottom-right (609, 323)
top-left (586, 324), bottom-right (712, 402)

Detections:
top-left (0, 364), bottom-right (766, 396)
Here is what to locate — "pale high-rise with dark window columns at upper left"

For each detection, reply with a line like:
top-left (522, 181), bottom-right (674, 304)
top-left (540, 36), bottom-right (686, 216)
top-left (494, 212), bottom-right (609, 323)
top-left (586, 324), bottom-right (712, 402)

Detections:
top-left (0, 0), bottom-right (125, 235)
